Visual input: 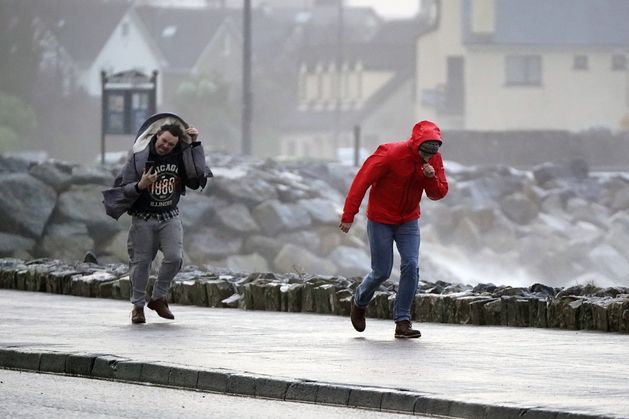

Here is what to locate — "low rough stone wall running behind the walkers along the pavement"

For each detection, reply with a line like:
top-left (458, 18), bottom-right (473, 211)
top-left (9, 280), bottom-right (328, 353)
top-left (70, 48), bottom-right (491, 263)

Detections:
top-left (0, 258), bottom-right (629, 333)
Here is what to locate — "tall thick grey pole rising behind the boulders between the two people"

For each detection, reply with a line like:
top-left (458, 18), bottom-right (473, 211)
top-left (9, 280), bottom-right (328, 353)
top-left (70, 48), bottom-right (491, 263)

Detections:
top-left (242, 0), bottom-right (253, 155)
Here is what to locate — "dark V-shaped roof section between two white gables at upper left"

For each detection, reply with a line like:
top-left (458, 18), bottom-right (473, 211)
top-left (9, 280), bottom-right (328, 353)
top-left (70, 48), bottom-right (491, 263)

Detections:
top-left (34, 0), bottom-right (130, 63)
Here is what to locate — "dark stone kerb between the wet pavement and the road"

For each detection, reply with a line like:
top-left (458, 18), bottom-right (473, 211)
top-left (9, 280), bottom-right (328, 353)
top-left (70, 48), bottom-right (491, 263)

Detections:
top-left (0, 348), bottom-right (602, 419)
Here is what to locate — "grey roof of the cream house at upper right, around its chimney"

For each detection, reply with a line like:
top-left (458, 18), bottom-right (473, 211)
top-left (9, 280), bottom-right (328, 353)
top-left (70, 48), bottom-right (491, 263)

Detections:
top-left (463, 0), bottom-right (629, 46)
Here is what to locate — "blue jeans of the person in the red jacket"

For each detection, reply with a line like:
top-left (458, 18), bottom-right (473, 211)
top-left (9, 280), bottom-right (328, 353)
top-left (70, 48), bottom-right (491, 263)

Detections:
top-left (354, 220), bottom-right (419, 322)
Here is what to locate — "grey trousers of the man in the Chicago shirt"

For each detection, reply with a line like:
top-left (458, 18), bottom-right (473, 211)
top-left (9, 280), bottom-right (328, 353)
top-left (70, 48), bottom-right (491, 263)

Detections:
top-left (127, 217), bottom-right (183, 307)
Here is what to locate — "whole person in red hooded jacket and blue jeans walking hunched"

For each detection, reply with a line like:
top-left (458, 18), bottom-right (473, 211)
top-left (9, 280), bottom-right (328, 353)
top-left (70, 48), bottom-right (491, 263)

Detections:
top-left (339, 121), bottom-right (448, 338)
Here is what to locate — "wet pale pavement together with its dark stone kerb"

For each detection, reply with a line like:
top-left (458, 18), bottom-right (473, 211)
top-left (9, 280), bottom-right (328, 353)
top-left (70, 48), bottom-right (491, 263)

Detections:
top-left (0, 290), bottom-right (629, 418)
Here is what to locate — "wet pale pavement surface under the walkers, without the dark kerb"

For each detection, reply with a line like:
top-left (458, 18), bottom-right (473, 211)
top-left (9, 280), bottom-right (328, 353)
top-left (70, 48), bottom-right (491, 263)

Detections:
top-left (0, 290), bottom-right (629, 417)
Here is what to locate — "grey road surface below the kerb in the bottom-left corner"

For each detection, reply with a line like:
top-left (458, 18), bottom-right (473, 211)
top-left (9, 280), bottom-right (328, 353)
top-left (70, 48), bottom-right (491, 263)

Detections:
top-left (0, 370), bottom-right (422, 419)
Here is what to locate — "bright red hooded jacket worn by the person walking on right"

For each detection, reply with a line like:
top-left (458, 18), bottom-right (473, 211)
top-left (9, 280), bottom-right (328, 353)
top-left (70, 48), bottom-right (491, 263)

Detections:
top-left (341, 121), bottom-right (448, 224)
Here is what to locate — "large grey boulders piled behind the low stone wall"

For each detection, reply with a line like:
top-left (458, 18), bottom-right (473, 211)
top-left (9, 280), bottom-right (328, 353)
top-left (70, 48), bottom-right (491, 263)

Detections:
top-left (0, 155), bottom-right (629, 287)
